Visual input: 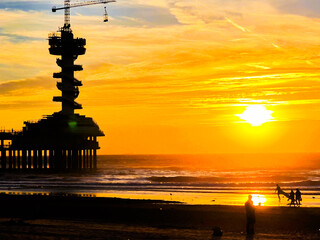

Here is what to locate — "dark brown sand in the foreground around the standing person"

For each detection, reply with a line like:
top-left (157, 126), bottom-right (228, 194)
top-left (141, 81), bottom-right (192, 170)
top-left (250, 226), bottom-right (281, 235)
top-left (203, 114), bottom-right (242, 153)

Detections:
top-left (0, 194), bottom-right (320, 239)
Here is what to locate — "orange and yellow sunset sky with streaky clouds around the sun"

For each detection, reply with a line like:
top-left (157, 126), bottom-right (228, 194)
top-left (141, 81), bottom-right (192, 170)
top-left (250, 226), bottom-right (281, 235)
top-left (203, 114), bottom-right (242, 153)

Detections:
top-left (0, 0), bottom-right (320, 154)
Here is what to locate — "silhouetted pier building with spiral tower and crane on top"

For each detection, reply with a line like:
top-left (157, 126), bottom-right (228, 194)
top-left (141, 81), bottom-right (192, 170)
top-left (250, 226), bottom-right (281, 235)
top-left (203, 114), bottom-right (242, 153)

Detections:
top-left (0, 0), bottom-right (115, 171)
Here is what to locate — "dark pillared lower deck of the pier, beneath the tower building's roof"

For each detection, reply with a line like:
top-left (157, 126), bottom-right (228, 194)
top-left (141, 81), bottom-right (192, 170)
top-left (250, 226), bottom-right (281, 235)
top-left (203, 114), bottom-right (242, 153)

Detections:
top-left (0, 120), bottom-right (99, 170)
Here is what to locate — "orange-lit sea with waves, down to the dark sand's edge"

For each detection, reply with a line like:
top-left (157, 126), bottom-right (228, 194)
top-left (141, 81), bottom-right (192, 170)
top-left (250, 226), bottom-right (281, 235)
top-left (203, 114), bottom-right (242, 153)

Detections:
top-left (0, 155), bottom-right (320, 207)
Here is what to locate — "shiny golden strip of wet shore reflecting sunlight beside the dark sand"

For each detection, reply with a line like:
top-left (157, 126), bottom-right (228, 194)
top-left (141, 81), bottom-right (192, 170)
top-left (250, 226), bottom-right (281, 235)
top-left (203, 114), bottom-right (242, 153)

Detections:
top-left (0, 188), bottom-right (320, 207)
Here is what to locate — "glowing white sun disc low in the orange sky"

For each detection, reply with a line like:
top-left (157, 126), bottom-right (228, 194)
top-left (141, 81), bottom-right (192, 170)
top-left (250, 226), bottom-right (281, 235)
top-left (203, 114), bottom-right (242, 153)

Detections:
top-left (236, 105), bottom-right (273, 126)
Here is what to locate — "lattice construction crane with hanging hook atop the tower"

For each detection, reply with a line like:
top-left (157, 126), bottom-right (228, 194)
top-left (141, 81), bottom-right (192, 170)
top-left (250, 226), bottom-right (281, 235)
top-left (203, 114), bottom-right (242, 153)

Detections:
top-left (52, 0), bottom-right (116, 28)
